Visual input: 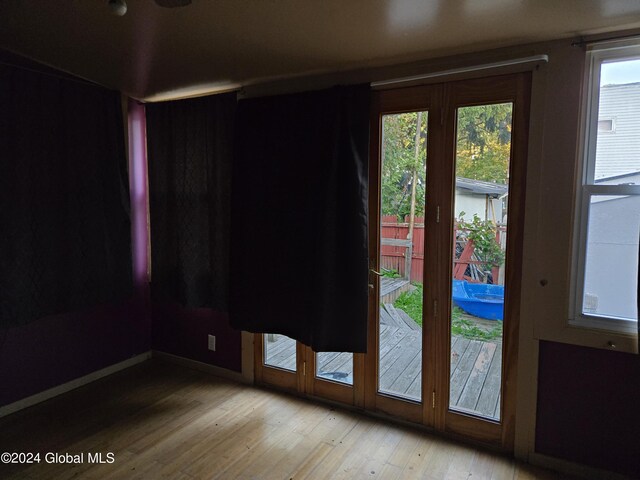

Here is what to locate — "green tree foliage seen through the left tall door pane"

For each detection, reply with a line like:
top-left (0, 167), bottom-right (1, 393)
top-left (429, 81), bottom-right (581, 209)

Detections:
top-left (381, 112), bottom-right (427, 221)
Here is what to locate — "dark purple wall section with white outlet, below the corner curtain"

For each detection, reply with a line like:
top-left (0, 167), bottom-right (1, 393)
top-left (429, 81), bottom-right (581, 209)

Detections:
top-left (152, 304), bottom-right (242, 372)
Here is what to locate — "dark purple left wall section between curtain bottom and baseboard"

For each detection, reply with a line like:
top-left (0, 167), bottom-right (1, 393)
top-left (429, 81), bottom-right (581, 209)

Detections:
top-left (0, 299), bottom-right (150, 406)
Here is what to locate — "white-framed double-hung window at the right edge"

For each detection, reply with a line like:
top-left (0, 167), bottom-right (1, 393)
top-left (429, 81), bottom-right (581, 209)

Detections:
top-left (570, 45), bottom-right (640, 333)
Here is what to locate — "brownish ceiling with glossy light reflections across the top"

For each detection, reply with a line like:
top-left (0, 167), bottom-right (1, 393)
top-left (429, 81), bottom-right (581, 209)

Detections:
top-left (0, 0), bottom-right (640, 98)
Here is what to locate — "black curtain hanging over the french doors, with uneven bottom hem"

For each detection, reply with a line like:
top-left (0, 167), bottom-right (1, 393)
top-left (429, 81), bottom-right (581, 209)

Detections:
top-left (230, 86), bottom-right (370, 352)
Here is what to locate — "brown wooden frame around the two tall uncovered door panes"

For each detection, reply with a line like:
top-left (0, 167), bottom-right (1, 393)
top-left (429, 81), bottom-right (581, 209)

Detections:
top-left (364, 72), bottom-right (531, 452)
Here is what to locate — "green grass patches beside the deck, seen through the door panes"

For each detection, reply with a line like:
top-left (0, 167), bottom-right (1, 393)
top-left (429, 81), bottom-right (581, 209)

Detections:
top-left (393, 283), bottom-right (502, 341)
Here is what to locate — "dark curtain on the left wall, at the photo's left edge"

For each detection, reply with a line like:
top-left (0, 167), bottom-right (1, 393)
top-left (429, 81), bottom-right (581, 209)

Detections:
top-left (0, 65), bottom-right (132, 327)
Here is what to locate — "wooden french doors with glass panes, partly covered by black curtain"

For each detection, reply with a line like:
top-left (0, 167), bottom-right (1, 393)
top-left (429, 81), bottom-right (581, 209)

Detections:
top-left (255, 74), bottom-right (530, 450)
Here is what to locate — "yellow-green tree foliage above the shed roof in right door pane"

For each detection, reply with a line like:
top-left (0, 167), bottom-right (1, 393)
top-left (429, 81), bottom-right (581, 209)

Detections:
top-left (456, 103), bottom-right (512, 184)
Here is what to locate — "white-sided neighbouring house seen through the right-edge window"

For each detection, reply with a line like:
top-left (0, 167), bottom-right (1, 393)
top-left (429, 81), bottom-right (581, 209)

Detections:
top-left (584, 83), bottom-right (640, 318)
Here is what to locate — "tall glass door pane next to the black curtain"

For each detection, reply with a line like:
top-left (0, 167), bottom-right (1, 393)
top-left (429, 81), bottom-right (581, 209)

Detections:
top-left (377, 112), bottom-right (427, 402)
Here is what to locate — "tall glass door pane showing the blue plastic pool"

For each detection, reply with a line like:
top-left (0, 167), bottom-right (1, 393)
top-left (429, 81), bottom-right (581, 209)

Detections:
top-left (449, 103), bottom-right (513, 421)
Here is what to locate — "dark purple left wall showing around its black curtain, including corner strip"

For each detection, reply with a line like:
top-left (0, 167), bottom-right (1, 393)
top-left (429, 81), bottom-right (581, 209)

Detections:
top-left (0, 72), bottom-right (151, 406)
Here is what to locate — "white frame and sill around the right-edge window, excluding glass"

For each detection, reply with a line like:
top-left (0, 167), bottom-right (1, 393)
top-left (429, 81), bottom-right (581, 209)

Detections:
top-left (563, 43), bottom-right (640, 351)
